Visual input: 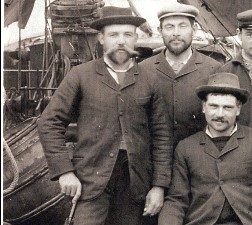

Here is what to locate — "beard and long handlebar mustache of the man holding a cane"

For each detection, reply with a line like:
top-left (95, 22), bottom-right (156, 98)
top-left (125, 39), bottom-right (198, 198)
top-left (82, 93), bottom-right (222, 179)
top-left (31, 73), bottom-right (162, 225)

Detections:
top-left (105, 45), bottom-right (139, 65)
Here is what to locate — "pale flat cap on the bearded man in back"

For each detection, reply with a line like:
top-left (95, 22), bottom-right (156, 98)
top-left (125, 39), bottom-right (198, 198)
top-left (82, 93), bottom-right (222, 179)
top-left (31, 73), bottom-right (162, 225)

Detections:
top-left (158, 2), bottom-right (199, 20)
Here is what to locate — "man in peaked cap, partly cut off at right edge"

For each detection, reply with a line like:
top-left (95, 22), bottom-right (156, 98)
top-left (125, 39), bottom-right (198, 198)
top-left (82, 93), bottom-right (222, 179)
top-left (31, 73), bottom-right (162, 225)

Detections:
top-left (219, 9), bottom-right (252, 127)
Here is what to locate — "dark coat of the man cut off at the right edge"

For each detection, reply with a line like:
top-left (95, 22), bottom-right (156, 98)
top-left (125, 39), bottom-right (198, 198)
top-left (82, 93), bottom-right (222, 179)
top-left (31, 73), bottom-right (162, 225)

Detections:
top-left (219, 54), bottom-right (252, 127)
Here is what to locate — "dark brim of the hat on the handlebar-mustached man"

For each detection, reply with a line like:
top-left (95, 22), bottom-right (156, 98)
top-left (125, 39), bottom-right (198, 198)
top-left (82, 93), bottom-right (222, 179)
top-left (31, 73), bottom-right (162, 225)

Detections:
top-left (90, 16), bottom-right (146, 30)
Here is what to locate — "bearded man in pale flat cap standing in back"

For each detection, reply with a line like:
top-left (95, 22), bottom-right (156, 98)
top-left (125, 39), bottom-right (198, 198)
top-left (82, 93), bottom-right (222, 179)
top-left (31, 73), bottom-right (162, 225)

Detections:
top-left (140, 3), bottom-right (221, 146)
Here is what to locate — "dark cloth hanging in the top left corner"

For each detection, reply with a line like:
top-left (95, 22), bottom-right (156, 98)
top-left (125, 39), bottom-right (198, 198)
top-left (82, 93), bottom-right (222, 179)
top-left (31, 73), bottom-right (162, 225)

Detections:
top-left (4, 0), bottom-right (35, 29)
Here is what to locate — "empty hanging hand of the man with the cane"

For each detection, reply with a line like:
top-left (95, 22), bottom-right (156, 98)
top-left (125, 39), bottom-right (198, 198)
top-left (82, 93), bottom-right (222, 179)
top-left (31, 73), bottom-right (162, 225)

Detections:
top-left (143, 187), bottom-right (164, 216)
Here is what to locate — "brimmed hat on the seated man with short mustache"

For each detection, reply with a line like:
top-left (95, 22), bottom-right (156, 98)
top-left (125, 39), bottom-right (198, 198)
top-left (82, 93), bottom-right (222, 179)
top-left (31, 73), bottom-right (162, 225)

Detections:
top-left (196, 72), bottom-right (249, 104)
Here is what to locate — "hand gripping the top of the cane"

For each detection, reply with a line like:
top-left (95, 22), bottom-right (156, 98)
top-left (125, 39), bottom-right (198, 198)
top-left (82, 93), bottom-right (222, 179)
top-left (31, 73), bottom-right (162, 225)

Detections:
top-left (59, 172), bottom-right (81, 203)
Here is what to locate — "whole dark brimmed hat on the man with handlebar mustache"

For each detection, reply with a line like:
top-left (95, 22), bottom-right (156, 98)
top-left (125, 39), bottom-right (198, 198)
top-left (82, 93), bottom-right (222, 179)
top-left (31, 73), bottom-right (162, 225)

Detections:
top-left (90, 6), bottom-right (146, 30)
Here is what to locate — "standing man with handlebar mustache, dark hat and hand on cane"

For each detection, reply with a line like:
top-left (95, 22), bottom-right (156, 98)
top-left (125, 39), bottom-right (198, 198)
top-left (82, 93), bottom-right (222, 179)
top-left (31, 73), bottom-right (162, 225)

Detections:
top-left (38, 6), bottom-right (172, 225)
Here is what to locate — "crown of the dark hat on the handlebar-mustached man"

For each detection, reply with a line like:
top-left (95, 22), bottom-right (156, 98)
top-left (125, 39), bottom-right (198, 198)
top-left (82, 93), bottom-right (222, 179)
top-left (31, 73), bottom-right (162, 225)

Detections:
top-left (100, 6), bottom-right (133, 18)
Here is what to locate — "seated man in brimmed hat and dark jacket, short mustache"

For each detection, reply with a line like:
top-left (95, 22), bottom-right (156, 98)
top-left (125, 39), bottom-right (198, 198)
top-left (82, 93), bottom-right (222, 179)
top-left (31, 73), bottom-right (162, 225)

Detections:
top-left (159, 73), bottom-right (252, 225)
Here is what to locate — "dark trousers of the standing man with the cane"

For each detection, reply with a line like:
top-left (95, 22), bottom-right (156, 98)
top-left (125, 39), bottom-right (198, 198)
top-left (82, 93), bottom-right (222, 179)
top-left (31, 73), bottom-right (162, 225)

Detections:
top-left (73, 150), bottom-right (154, 225)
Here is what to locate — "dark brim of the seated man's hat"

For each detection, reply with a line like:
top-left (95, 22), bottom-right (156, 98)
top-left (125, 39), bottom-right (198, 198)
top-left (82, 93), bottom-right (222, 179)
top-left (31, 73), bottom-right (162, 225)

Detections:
top-left (195, 85), bottom-right (249, 104)
